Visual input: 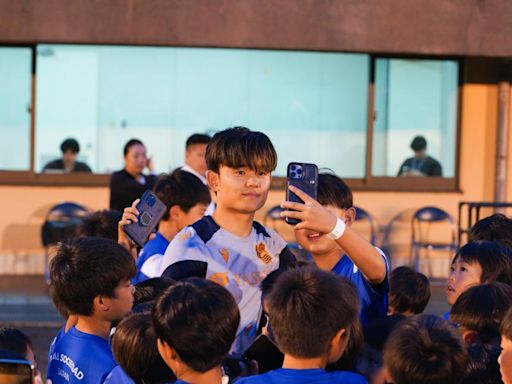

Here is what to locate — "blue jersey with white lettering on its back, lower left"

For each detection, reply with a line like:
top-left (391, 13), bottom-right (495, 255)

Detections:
top-left (46, 327), bottom-right (116, 384)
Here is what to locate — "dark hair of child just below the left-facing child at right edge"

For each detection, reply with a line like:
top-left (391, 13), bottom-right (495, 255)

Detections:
top-left (450, 282), bottom-right (512, 343)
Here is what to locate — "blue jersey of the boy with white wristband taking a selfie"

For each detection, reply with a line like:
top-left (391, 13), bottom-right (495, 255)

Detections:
top-left (332, 248), bottom-right (389, 326)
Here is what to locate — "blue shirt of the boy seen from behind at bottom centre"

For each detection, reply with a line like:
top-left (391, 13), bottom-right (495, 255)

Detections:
top-left (237, 368), bottom-right (366, 384)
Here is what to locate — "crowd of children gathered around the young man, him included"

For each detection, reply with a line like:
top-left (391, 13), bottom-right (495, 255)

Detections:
top-left (4, 127), bottom-right (512, 384)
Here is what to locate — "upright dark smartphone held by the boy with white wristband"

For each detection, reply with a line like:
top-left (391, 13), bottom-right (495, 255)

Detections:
top-left (285, 162), bottom-right (318, 225)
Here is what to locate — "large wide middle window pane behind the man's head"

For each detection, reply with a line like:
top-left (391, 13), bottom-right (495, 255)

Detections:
top-left (36, 45), bottom-right (369, 177)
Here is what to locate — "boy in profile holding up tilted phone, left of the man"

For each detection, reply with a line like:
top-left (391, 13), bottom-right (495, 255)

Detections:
top-left (120, 169), bottom-right (211, 284)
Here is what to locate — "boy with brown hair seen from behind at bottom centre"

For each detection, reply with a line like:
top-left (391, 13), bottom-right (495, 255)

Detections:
top-left (237, 266), bottom-right (366, 384)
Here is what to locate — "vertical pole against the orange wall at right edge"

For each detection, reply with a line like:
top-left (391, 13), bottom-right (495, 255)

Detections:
top-left (494, 81), bottom-right (510, 213)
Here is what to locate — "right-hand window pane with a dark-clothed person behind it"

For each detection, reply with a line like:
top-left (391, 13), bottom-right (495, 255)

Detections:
top-left (372, 59), bottom-right (458, 178)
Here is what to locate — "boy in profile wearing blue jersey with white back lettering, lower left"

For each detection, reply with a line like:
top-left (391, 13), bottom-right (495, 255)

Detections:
top-left (47, 237), bottom-right (135, 384)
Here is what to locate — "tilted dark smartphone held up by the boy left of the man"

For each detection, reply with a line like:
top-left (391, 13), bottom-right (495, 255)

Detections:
top-left (123, 190), bottom-right (167, 247)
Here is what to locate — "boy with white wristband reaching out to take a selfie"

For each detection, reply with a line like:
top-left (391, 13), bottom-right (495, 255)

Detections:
top-left (281, 173), bottom-right (389, 326)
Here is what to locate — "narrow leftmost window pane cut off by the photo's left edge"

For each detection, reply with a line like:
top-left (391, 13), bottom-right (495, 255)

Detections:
top-left (0, 47), bottom-right (32, 171)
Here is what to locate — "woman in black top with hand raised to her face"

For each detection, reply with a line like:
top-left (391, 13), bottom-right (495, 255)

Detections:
top-left (110, 139), bottom-right (156, 212)
